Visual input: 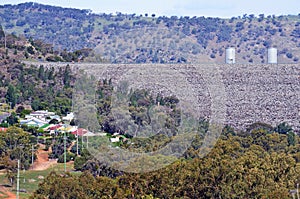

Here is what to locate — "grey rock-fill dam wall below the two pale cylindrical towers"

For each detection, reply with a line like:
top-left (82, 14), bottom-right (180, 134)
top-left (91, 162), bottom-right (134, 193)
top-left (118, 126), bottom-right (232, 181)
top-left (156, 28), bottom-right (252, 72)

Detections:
top-left (27, 63), bottom-right (300, 131)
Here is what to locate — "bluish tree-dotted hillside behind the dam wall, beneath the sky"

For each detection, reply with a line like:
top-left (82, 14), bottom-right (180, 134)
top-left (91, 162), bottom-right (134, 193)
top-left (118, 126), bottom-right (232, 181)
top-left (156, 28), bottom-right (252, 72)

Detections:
top-left (0, 3), bottom-right (300, 64)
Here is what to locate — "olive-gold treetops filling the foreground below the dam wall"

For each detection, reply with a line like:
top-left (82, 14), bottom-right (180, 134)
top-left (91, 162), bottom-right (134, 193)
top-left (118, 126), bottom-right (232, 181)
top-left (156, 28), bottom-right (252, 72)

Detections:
top-left (31, 125), bottom-right (300, 198)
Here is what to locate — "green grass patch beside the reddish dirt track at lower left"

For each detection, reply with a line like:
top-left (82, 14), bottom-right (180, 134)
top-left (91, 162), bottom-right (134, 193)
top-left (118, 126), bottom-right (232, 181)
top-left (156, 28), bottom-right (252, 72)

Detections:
top-left (0, 163), bottom-right (80, 199)
